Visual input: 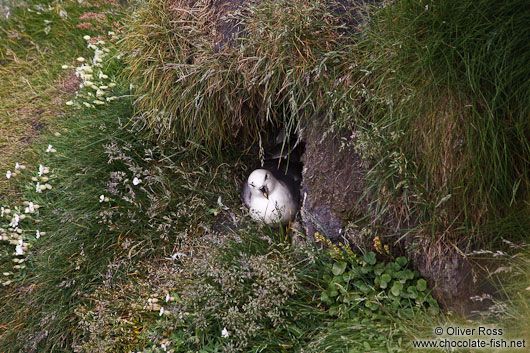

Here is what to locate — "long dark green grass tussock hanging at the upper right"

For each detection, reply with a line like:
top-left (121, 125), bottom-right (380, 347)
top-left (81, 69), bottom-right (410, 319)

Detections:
top-left (342, 0), bottom-right (530, 240)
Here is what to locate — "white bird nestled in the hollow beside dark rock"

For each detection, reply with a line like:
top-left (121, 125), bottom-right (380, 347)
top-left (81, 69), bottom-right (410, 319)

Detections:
top-left (241, 168), bottom-right (299, 224)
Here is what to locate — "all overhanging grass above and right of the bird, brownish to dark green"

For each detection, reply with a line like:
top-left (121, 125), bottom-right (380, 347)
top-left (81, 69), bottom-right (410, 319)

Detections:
top-left (123, 0), bottom-right (530, 244)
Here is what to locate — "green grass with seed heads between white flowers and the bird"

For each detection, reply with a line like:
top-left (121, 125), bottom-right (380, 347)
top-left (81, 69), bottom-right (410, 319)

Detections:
top-left (0, 71), bottom-right (241, 351)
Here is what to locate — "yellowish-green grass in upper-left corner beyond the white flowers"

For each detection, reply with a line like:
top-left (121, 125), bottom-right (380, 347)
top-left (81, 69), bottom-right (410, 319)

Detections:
top-left (0, 1), bottom-right (117, 200)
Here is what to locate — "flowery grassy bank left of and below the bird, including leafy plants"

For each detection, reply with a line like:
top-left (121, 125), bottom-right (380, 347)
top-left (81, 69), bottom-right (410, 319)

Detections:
top-left (0, 13), bottom-right (437, 346)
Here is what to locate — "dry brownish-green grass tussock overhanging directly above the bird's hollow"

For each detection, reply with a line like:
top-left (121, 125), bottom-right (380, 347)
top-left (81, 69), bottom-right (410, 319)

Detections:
top-left (123, 0), bottom-right (356, 151)
